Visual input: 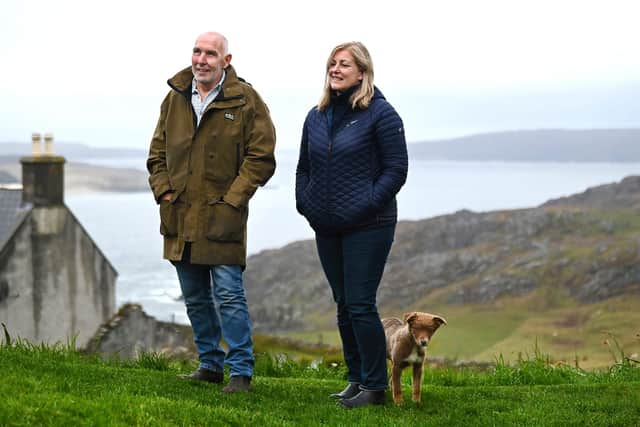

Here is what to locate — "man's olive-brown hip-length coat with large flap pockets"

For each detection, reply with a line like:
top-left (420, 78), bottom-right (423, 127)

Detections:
top-left (147, 66), bottom-right (275, 266)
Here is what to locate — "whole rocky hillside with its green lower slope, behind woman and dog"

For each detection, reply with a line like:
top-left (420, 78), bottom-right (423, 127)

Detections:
top-left (245, 176), bottom-right (640, 365)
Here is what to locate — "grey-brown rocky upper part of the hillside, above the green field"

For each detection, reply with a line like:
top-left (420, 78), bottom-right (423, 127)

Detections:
top-left (245, 177), bottom-right (640, 333)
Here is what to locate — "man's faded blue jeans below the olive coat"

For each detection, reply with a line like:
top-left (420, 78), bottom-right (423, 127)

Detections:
top-left (173, 260), bottom-right (254, 377)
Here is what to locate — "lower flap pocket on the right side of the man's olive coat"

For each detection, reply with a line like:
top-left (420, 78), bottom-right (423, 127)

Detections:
top-left (206, 200), bottom-right (246, 242)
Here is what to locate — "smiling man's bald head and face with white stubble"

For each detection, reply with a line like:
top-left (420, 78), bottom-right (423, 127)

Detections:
top-left (191, 34), bottom-right (231, 89)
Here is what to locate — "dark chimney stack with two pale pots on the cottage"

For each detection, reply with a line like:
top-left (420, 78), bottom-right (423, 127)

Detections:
top-left (20, 133), bottom-right (65, 206)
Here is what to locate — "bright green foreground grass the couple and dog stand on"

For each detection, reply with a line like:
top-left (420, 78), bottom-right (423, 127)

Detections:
top-left (0, 337), bottom-right (640, 426)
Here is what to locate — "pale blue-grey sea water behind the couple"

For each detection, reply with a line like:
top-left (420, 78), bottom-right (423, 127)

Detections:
top-left (66, 155), bottom-right (640, 323)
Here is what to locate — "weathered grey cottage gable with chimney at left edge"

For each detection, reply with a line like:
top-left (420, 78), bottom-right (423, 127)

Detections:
top-left (0, 136), bottom-right (117, 347)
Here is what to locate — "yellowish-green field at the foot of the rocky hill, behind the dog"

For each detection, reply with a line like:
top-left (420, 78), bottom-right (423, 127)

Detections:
top-left (282, 295), bottom-right (640, 369)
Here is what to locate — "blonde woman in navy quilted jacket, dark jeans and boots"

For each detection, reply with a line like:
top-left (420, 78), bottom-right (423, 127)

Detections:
top-left (296, 42), bottom-right (408, 408)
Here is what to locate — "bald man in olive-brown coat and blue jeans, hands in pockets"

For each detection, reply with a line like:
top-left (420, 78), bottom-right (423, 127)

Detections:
top-left (147, 32), bottom-right (275, 392)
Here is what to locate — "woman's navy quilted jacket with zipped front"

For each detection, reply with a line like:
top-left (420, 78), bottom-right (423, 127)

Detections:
top-left (296, 88), bottom-right (408, 233)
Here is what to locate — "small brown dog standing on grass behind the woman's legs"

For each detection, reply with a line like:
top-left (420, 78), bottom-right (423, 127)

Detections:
top-left (382, 312), bottom-right (447, 404)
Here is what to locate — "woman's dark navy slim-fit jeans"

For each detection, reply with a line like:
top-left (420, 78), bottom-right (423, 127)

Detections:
top-left (316, 224), bottom-right (395, 390)
